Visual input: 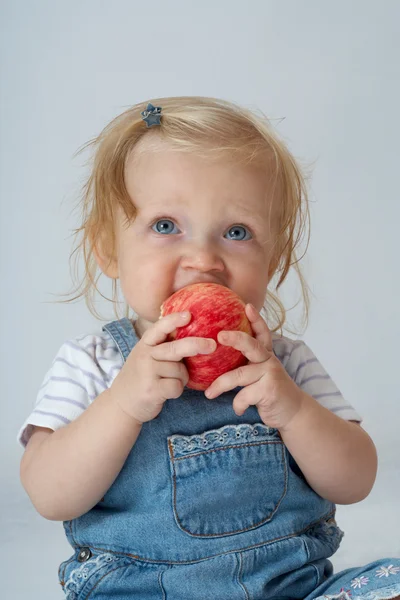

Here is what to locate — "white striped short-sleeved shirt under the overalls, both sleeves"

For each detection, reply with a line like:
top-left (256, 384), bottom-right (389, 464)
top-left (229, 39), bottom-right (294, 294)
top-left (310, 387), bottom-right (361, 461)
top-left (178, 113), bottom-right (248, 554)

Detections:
top-left (18, 332), bottom-right (362, 447)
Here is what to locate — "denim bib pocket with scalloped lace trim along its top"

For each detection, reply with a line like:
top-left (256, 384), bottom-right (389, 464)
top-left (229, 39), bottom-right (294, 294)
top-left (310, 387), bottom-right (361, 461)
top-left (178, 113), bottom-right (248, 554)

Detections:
top-left (168, 423), bottom-right (288, 537)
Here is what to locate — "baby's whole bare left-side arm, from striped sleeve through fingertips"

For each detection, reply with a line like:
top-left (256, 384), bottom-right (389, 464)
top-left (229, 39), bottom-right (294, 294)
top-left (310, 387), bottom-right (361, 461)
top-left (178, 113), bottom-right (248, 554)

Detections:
top-left (21, 313), bottom-right (216, 521)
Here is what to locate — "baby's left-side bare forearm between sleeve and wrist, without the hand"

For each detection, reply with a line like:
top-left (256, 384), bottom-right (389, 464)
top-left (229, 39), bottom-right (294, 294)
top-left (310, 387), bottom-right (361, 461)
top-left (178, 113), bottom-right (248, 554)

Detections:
top-left (20, 390), bottom-right (141, 521)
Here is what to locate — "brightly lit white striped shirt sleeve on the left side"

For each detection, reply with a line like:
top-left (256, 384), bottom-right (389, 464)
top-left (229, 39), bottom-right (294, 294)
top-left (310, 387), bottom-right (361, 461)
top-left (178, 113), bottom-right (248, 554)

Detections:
top-left (17, 336), bottom-right (119, 447)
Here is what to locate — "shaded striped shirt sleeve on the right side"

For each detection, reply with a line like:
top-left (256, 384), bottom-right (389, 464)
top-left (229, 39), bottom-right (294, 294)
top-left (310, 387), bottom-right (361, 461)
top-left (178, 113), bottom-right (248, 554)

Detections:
top-left (274, 340), bottom-right (363, 423)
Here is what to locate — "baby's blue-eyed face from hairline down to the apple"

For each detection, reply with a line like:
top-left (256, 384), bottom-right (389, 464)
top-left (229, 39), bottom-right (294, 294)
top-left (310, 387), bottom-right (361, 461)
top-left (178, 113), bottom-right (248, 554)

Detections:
top-left (104, 145), bottom-right (274, 335)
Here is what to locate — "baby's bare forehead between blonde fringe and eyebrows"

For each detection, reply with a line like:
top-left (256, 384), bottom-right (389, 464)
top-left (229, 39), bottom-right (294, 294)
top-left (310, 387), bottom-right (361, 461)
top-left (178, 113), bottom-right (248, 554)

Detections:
top-left (125, 132), bottom-right (279, 225)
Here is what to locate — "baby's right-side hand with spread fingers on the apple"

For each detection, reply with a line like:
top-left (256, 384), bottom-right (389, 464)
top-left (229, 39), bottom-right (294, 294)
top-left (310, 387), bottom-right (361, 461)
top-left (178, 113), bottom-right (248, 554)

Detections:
top-left (205, 304), bottom-right (303, 429)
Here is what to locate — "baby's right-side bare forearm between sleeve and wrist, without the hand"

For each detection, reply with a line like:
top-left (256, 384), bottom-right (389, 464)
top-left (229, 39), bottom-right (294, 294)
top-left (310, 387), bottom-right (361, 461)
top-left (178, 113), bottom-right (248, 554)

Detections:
top-left (280, 393), bottom-right (378, 504)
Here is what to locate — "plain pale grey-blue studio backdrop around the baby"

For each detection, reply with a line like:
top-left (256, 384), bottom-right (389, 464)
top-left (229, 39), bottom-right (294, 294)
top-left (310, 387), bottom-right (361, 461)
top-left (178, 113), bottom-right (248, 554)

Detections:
top-left (0, 0), bottom-right (400, 600)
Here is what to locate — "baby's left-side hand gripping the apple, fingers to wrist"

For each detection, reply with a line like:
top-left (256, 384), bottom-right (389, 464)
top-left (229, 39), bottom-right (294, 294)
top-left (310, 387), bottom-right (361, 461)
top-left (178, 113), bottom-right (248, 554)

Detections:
top-left (110, 312), bottom-right (217, 424)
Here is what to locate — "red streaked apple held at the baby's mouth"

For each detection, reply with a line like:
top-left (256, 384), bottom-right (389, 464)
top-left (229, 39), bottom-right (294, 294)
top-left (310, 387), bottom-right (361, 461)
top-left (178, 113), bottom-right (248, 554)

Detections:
top-left (161, 283), bottom-right (253, 391)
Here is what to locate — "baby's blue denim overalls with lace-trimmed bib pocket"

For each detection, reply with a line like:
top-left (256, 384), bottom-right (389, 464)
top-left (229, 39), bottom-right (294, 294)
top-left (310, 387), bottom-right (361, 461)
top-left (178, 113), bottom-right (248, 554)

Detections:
top-left (59, 319), bottom-right (400, 600)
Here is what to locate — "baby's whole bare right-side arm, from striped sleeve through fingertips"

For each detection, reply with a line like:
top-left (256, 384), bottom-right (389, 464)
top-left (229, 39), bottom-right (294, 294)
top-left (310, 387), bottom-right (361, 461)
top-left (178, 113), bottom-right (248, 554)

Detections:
top-left (205, 304), bottom-right (377, 504)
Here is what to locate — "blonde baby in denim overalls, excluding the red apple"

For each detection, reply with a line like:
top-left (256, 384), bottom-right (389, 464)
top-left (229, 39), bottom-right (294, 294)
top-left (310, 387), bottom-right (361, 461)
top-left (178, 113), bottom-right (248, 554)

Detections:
top-left (19, 97), bottom-right (400, 600)
